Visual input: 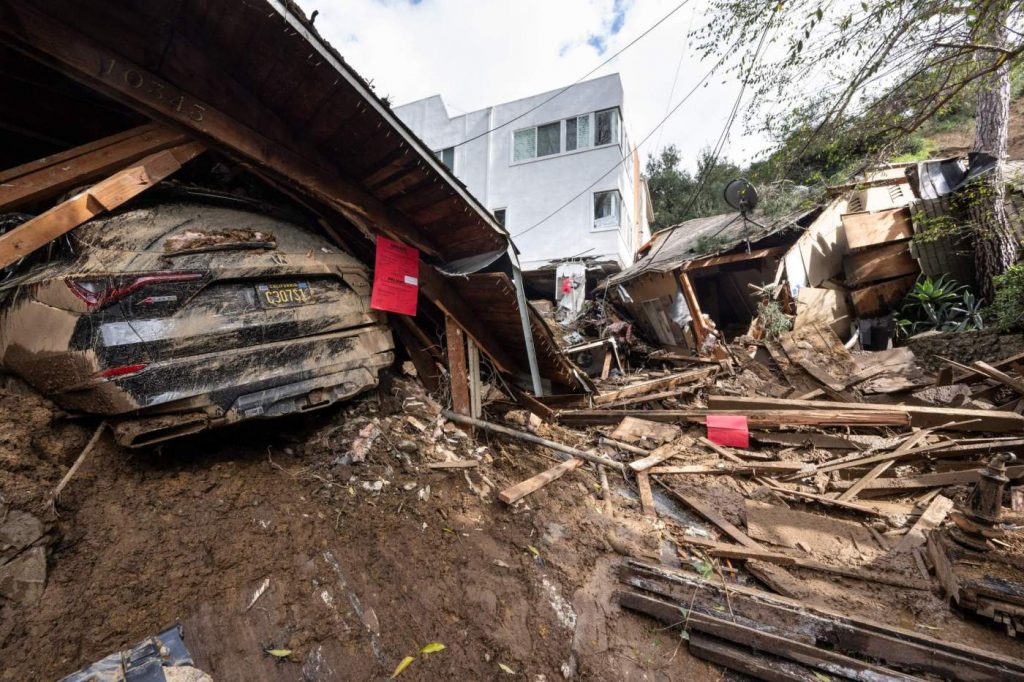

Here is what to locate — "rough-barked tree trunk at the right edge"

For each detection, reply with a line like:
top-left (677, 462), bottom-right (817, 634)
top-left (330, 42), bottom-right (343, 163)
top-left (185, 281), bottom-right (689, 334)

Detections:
top-left (972, 15), bottom-right (1019, 301)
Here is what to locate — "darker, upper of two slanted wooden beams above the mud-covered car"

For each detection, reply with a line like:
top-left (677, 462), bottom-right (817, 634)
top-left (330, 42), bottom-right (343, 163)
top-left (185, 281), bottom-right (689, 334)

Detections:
top-left (0, 124), bottom-right (188, 206)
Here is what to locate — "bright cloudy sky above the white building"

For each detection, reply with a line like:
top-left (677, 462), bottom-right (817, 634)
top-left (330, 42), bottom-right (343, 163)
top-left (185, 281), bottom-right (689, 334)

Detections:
top-left (299, 0), bottom-right (767, 171)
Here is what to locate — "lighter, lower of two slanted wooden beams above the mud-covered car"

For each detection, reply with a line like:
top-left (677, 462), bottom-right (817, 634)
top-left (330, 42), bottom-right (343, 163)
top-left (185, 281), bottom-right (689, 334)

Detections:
top-left (0, 142), bottom-right (205, 267)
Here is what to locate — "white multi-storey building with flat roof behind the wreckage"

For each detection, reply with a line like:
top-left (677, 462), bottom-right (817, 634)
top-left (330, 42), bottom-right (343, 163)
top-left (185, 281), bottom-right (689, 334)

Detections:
top-left (394, 74), bottom-right (651, 284)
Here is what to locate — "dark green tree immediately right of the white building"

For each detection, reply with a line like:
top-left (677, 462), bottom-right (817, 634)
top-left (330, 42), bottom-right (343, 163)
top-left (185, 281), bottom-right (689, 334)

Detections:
top-left (644, 144), bottom-right (741, 231)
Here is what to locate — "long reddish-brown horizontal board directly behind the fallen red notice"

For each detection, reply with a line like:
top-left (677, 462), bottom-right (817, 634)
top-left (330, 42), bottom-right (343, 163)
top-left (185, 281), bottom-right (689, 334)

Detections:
top-left (558, 402), bottom-right (909, 429)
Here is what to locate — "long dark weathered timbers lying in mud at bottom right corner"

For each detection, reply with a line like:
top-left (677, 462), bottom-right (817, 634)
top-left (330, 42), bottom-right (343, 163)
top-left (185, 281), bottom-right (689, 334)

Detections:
top-left (616, 561), bottom-right (1024, 682)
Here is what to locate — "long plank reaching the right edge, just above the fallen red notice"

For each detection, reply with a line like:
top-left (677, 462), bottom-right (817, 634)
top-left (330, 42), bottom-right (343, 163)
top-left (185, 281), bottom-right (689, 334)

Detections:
top-left (708, 395), bottom-right (1024, 432)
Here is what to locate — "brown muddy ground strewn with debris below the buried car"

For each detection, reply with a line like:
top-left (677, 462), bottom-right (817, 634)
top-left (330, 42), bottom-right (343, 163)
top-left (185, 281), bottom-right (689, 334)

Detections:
top-left (0, 372), bottom-right (1024, 682)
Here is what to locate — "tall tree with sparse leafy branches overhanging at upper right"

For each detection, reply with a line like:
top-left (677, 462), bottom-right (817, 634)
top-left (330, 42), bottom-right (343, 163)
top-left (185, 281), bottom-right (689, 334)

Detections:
top-left (692, 0), bottom-right (1024, 292)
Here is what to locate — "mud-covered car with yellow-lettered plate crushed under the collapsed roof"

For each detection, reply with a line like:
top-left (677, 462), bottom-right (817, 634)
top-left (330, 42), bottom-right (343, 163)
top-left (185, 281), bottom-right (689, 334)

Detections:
top-left (0, 192), bottom-right (393, 445)
